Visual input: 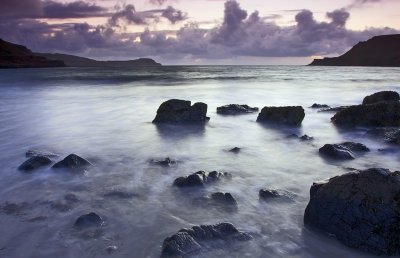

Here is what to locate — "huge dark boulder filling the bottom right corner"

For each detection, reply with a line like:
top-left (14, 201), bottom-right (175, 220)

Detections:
top-left (304, 168), bottom-right (400, 255)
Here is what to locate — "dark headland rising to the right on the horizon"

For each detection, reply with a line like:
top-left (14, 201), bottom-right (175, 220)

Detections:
top-left (310, 34), bottom-right (400, 67)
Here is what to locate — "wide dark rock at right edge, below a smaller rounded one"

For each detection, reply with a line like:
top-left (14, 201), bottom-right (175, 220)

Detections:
top-left (331, 101), bottom-right (400, 126)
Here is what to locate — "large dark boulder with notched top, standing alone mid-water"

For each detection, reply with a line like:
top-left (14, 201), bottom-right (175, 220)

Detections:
top-left (153, 99), bottom-right (209, 124)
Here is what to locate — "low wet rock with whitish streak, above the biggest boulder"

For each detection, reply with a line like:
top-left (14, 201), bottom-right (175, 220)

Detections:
top-left (319, 142), bottom-right (369, 160)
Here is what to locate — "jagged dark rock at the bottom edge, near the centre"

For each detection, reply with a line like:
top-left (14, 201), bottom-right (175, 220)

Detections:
top-left (161, 223), bottom-right (252, 257)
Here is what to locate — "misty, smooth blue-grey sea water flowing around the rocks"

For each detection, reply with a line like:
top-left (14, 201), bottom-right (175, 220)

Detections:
top-left (0, 66), bottom-right (400, 257)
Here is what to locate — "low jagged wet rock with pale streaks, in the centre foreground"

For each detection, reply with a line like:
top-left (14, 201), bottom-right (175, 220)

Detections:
top-left (174, 171), bottom-right (232, 187)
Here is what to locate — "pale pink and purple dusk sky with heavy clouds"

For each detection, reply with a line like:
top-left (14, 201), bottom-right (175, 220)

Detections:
top-left (0, 0), bottom-right (400, 65)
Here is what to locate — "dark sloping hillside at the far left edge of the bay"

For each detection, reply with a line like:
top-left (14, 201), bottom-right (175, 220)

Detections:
top-left (0, 39), bottom-right (65, 68)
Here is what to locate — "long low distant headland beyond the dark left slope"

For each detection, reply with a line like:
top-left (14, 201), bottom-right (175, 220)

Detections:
top-left (36, 53), bottom-right (161, 67)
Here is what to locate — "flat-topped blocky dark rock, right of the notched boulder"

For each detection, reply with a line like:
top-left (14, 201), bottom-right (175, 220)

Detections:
top-left (257, 106), bottom-right (305, 126)
